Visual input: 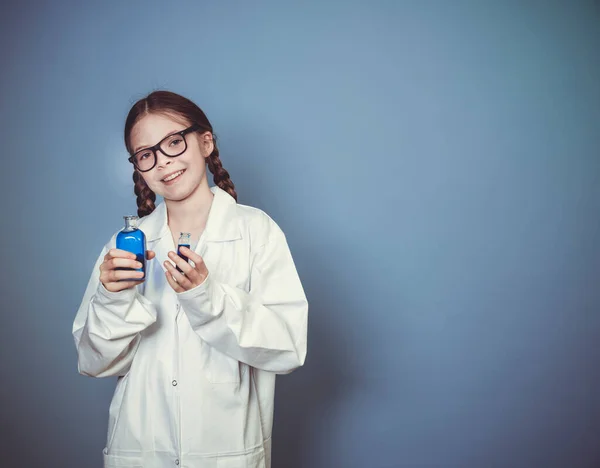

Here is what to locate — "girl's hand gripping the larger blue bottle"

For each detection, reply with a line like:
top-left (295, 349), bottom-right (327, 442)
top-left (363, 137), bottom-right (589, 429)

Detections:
top-left (100, 249), bottom-right (155, 292)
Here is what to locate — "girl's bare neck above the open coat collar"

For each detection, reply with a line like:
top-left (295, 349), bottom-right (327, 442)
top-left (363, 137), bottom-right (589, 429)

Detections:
top-left (165, 177), bottom-right (214, 235)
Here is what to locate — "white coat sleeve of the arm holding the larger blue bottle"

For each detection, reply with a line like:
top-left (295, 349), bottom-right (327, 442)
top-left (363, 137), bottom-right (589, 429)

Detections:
top-left (73, 245), bottom-right (156, 377)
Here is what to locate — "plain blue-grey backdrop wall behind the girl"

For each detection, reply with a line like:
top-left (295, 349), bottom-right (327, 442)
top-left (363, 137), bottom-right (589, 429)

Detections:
top-left (0, 0), bottom-right (600, 468)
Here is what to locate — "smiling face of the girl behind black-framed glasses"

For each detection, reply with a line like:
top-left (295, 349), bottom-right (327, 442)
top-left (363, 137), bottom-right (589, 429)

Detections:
top-left (130, 114), bottom-right (213, 200)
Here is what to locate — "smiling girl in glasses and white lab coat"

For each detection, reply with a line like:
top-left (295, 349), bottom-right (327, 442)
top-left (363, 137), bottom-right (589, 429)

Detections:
top-left (73, 91), bottom-right (308, 468)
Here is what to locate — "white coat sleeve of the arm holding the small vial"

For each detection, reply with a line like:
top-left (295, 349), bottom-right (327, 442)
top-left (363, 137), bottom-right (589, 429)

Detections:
top-left (178, 226), bottom-right (308, 374)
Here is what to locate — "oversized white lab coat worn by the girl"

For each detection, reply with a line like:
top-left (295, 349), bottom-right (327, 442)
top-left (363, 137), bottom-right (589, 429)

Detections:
top-left (73, 187), bottom-right (308, 468)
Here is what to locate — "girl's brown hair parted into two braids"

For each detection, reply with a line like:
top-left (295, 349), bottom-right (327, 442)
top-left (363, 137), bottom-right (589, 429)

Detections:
top-left (125, 91), bottom-right (237, 218)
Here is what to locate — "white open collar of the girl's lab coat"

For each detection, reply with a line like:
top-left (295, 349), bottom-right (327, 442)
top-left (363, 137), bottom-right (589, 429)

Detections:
top-left (139, 186), bottom-right (242, 242)
